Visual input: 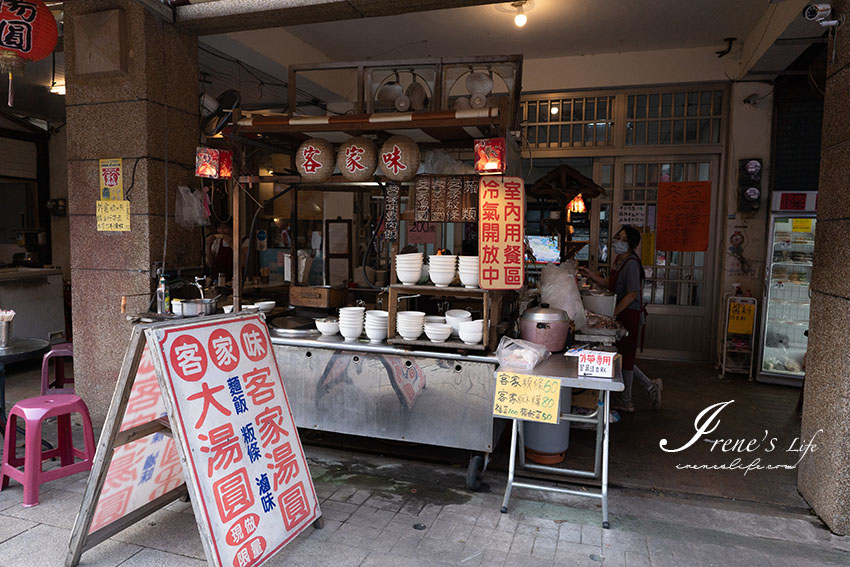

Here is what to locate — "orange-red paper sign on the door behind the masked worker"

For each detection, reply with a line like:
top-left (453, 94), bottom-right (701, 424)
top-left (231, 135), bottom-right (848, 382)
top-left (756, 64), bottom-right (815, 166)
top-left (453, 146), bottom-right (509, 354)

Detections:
top-left (655, 181), bottom-right (711, 252)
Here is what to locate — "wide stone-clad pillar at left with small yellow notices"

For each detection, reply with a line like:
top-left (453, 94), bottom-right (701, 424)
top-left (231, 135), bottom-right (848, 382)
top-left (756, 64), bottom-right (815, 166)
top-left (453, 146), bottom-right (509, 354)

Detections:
top-left (65, 0), bottom-right (201, 423)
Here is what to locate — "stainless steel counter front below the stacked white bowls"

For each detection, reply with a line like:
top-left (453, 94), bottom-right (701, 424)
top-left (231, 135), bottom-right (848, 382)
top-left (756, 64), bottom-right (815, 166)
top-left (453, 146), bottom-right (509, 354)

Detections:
top-left (272, 336), bottom-right (498, 453)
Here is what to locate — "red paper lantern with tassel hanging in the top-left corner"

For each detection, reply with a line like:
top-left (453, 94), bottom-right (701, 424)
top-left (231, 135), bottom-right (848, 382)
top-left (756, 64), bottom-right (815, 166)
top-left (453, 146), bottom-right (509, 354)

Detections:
top-left (0, 0), bottom-right (58, 106)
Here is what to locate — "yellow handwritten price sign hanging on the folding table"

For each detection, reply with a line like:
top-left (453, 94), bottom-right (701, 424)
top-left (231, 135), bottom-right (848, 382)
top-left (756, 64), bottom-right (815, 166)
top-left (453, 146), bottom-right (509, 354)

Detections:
top-left (493, 371), bottom-right (561, 423)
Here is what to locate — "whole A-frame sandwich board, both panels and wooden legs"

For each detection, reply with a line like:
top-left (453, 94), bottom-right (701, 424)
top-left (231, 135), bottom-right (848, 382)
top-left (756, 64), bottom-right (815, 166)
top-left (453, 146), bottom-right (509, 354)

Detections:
top-left (66, 314), bottom-right (321, 567)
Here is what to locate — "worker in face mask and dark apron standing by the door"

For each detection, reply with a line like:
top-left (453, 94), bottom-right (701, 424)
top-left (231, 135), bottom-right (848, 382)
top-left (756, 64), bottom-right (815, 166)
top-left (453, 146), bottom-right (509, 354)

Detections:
top-left (579, 225), bottom-right (662, 413)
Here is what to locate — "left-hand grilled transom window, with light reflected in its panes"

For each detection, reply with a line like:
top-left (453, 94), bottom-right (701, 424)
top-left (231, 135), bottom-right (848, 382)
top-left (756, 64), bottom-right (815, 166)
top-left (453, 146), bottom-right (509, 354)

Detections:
top-left (520, 96), bottom-right (614, 149)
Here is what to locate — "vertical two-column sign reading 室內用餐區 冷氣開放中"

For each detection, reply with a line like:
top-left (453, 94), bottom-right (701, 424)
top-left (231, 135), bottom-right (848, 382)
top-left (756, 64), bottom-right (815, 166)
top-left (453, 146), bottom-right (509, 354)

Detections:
top-left (478, 176), bottom-right (525, 289)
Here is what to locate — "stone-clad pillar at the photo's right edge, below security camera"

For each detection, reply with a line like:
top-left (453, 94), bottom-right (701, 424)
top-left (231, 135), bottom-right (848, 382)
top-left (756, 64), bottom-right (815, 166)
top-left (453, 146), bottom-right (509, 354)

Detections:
top-left (797, 0), bottom-right (850, 534)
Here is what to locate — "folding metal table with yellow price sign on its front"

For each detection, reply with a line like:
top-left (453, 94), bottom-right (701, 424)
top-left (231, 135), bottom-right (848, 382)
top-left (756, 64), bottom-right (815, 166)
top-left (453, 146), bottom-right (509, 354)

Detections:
top-left (496, 354), bottom-right (624, 529)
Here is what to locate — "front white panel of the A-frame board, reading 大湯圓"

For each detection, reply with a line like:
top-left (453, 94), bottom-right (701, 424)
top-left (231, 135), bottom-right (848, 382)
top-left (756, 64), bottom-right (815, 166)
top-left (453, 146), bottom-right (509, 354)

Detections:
top-left (148, 315), bottom-right (321, 567)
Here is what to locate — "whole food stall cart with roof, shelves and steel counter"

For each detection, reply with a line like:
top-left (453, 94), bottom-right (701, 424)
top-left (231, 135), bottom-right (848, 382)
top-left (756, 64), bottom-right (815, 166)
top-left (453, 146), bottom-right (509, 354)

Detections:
top-left (229, 56), bottom-right (522, 489)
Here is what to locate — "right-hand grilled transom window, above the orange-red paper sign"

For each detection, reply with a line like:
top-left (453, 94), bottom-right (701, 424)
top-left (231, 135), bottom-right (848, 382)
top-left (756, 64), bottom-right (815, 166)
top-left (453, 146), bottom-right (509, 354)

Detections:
top-left (626, 90), bottom-right (723, 146)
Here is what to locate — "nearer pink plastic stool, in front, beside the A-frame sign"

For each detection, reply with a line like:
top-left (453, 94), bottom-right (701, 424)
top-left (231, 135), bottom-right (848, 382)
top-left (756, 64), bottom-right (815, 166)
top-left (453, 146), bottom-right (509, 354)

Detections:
top-left (0, 394), bottom-right (94, 507)
